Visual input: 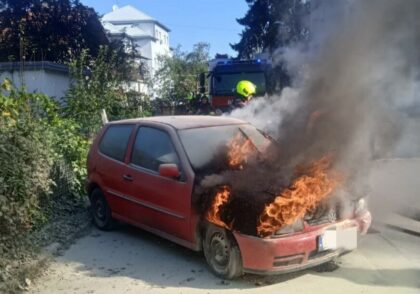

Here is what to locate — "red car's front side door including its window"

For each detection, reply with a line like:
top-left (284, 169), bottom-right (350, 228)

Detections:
top-left (122, 126), bottom-right (192, 240)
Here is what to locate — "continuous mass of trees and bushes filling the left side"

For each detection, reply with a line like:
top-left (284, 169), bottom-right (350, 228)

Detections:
top-left (0, 0), bottom-right (151, 293)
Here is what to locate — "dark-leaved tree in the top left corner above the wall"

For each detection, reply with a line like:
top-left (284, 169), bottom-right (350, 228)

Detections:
top-left (0, 0), bottom-right (108, 63)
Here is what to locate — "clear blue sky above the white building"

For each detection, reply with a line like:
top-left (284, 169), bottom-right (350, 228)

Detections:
top-left (81, 0), bottom-right (248, 57)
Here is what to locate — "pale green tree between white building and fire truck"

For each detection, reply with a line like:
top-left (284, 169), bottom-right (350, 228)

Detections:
top-left (154, 43), bottom-right (210, 102)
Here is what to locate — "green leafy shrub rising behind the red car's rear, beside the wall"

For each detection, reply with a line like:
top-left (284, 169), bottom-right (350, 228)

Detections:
top-left (64, 43), bottom-right (149, 137)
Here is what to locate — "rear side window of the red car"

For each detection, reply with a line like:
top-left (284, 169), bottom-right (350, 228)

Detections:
top-left (99, 125), bottom-right (134, 161)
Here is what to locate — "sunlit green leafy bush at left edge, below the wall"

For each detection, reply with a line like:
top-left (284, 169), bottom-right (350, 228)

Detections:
top-left (0, 82), bottom-right (52, 251)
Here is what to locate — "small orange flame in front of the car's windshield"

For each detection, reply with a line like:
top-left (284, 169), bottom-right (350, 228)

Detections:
top-left (228, 133), bottom-right (255, 169)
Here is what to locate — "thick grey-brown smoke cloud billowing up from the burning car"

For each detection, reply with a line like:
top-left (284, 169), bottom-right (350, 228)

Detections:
top-left (231, 0), bottom-right (420, 216)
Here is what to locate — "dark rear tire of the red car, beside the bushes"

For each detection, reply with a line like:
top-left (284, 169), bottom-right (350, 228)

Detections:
top-left (90, 189), bottom-right (116, 231)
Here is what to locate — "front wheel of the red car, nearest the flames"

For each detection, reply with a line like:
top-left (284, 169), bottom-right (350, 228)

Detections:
top-left (203, 224), bottom-right (243, 280)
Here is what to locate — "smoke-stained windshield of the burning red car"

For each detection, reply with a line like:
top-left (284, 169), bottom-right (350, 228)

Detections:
top-left (178, 124), bottom-right (271, 172)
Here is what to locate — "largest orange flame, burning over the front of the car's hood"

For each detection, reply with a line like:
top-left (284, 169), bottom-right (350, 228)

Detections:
top-left (257, 156), bottom-right (340, 237)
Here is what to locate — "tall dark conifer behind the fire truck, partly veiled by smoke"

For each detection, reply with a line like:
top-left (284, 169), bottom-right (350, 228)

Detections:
top-left (231, 0), bottom-right (310, 58)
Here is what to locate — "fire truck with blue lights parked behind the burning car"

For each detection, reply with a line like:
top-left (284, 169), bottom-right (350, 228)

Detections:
top-left (200, 59), bottom-right (271, 112)
